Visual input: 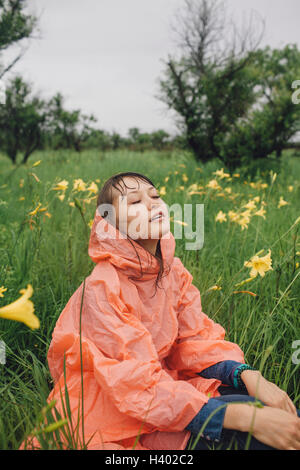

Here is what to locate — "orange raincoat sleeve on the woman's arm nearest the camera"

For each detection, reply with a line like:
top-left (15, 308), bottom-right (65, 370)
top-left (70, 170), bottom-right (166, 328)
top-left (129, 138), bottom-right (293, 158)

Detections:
top-left (57, 281), bottom-right (213, 432)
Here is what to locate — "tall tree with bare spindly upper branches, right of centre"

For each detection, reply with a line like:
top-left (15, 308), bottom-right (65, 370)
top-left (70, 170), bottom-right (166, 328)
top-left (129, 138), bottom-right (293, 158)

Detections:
top-left (158, 0), bottom-right (261, 171)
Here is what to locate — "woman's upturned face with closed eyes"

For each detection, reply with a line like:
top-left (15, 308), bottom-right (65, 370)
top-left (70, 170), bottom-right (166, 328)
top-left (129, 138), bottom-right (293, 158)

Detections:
top-left (113, 176), bottom-right (170, 240)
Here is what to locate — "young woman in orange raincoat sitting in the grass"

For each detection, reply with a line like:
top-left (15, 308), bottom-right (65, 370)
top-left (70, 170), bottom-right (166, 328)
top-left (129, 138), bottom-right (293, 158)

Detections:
top-left (38, 172), bottom-right (300, 450)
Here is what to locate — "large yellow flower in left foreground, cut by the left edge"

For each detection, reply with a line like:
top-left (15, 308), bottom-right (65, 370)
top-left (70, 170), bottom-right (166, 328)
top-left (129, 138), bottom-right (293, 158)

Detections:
top-left (0, 284), bottom-right (40, 329)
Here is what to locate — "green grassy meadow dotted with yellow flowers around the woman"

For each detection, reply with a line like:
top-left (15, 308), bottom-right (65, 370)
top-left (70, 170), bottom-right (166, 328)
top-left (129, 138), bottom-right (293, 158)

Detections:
top-left (0, 150), bottom-right (300, 450)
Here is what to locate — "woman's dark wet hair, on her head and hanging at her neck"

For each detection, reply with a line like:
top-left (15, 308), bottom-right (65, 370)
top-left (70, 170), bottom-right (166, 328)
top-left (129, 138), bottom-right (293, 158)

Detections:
top-left (97, 171), bottom-right (170, 297)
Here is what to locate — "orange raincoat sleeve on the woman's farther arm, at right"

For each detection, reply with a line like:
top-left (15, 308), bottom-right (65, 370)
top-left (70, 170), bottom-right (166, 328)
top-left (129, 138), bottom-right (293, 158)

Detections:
top-left (167, 258), bottom-right (245, 377)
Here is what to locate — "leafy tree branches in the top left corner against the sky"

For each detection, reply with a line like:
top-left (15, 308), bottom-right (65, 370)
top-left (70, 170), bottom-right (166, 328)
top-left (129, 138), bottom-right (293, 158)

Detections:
top-left (0, 0), bottom-right (37, 80)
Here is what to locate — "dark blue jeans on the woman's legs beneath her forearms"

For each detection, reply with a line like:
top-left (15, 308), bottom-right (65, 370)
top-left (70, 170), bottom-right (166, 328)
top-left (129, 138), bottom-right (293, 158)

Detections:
top-left (185, 386), bottom-right (300, 450)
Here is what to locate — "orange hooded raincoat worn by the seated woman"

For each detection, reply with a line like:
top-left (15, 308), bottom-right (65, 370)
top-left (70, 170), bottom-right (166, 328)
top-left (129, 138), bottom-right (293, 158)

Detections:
top-left (24, 210), bottom-right (244, 450)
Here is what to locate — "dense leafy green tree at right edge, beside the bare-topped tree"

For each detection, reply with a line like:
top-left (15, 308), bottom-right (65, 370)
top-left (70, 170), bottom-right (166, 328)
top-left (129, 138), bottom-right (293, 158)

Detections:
top-left (222, 45), bottom-right (300, 176)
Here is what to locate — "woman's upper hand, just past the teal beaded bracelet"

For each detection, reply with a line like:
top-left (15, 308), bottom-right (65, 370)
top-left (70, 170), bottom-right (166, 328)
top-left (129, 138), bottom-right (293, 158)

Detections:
top-left (241, 370), bottom-right (298, 416)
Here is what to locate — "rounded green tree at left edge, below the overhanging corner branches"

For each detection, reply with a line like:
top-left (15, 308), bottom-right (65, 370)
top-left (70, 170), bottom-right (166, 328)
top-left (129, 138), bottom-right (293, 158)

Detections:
top-left (0, 76), bottom-right (46, 164)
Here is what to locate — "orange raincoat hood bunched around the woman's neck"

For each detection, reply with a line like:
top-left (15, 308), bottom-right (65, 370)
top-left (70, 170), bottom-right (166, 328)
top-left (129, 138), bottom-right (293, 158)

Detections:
top-left (88, 210), bottom-right (176, 279)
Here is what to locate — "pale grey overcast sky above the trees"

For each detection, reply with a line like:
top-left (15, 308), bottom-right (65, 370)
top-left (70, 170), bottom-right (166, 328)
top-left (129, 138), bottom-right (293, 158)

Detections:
top-left (2, 0), bottom-right (300, 136)
